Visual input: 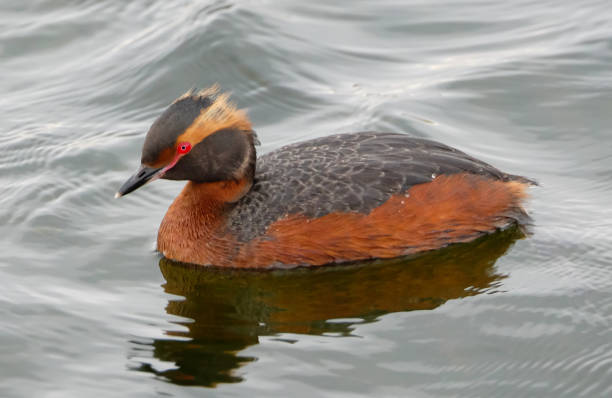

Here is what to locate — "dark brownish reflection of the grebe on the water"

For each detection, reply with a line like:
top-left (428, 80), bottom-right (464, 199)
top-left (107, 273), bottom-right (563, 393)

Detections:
top-left (132, 228), bottom-right (523, 386)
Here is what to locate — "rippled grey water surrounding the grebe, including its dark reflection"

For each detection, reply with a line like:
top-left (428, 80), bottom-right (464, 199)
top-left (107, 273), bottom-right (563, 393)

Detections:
top-left (0, 0), bottom-right (612, 397)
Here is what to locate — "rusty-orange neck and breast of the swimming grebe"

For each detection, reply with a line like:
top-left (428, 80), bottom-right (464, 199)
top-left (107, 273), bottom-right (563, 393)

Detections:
top-left (157, 178), bottom-right (253, 264)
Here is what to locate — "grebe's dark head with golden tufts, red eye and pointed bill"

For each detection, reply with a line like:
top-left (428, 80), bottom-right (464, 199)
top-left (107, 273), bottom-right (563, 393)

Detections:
top-left (115, 86), bottom-right (257, 197)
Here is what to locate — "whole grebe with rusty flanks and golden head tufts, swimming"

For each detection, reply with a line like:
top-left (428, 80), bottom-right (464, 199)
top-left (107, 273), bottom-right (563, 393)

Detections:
top-left (115, 85), bottom-right (537, 269)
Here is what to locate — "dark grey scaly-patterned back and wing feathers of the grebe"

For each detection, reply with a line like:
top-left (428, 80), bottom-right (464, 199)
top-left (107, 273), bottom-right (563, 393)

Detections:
top-left (228, 132), bottom-right (526, 241)
